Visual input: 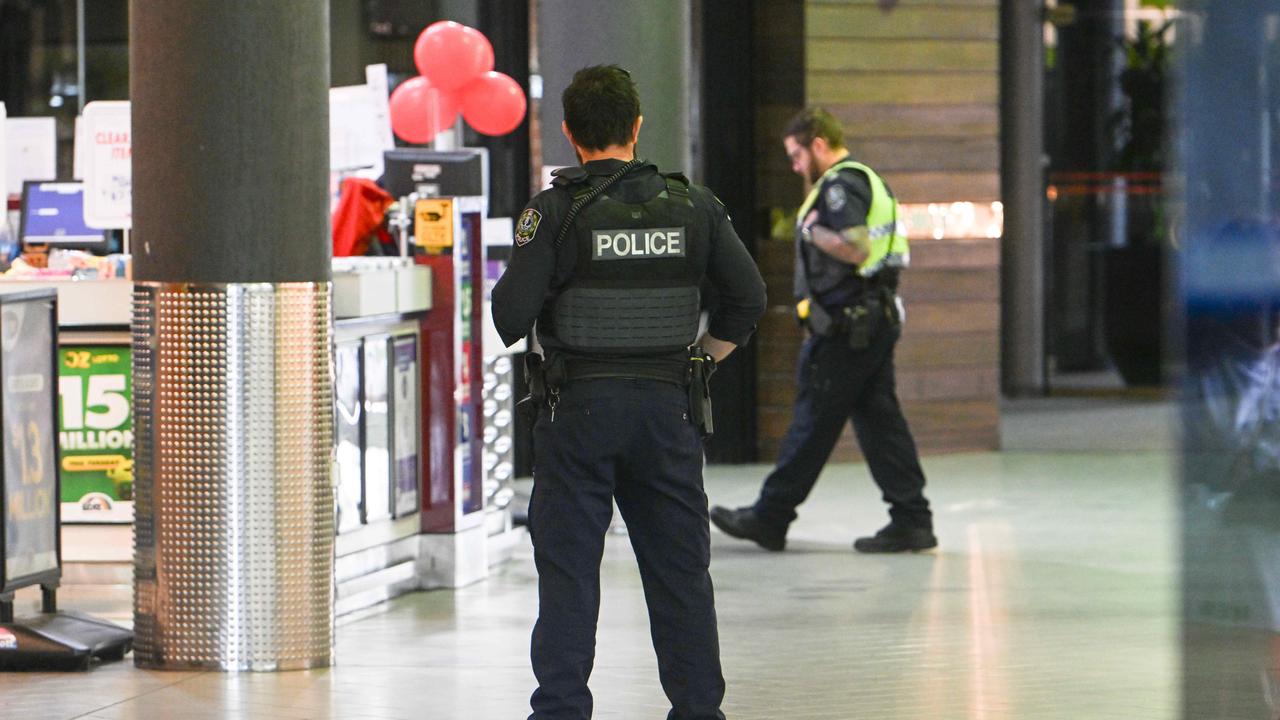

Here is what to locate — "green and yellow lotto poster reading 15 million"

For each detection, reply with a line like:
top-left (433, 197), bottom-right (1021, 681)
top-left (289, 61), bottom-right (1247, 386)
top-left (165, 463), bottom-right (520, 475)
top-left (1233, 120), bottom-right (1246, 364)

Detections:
top-left (58, 346), bottom-right (133, 521)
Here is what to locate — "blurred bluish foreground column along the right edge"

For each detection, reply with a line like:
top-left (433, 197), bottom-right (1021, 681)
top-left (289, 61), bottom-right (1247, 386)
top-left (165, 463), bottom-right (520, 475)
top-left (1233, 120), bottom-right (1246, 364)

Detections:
top-left (1174, 0), bottom-right (1280, 719)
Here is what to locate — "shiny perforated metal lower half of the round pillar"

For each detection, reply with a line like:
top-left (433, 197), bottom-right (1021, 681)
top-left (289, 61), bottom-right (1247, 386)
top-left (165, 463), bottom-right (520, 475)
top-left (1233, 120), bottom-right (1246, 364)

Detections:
top-left (133, 283), bottom-right (334, 670)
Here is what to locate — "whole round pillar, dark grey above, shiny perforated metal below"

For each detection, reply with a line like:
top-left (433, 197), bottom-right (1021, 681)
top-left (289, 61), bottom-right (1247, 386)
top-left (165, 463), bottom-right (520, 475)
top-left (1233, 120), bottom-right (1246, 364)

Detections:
top-left (129, 0), bottom-right (334, 670)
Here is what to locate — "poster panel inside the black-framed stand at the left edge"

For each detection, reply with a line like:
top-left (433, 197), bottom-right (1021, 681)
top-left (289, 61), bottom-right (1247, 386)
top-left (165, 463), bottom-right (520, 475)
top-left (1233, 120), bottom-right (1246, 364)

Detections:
top-left (0, 299), bottom-right (58, 591)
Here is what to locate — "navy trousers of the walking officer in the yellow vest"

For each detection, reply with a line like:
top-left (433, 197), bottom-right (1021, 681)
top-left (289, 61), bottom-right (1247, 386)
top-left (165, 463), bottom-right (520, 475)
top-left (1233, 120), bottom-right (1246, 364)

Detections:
top-left (755, 327), bottom-right (933, 529)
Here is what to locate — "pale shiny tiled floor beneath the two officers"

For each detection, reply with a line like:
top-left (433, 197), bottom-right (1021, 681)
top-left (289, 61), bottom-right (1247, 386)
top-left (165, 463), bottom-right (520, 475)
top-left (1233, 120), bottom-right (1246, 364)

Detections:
top-left (0, 394), bottom-right (1179, 720)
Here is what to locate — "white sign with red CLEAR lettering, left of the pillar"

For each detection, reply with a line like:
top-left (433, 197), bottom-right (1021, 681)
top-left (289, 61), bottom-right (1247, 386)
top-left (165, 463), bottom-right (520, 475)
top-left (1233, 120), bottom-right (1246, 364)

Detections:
top-left (82, 100), bottom-right (133, 229)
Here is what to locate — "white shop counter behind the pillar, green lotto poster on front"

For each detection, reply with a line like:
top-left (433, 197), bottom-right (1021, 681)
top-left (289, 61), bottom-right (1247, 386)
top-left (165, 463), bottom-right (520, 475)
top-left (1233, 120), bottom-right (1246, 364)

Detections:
top-left (0, 230), bottom-right (524, 618)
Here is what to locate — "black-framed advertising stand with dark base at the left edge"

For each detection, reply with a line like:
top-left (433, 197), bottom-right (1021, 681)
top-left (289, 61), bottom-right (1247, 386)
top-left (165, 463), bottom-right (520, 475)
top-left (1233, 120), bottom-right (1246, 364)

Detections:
top-left (0, 290), bottom-right (133, 670)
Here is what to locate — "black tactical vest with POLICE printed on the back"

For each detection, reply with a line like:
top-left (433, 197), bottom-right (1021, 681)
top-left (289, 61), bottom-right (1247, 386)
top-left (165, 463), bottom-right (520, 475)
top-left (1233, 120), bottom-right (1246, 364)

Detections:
top-left (539, 170), bottom-right (703, 357)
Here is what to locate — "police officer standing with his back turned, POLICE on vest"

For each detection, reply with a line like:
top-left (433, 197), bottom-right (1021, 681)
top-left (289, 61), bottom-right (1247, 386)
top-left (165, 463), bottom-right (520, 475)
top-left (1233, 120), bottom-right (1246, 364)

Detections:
top-left (493, 65), bottom-right (764, 720)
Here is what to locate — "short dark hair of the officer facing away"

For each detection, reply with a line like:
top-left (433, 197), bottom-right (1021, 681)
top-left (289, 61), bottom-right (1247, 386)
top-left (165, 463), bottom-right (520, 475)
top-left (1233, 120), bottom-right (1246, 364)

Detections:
top-left (561, 65), bottom-right (640, 150)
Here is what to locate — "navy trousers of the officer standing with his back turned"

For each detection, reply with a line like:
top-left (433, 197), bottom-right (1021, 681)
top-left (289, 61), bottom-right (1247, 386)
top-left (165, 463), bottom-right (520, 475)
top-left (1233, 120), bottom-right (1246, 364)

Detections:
top-left (529, 379), bottom-right (724, 720)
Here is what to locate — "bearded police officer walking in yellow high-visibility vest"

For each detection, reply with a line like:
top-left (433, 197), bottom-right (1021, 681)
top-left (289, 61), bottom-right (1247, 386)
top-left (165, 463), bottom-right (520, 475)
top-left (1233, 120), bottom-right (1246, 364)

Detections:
top-left (710, 108), bottom-right (937, 552)
